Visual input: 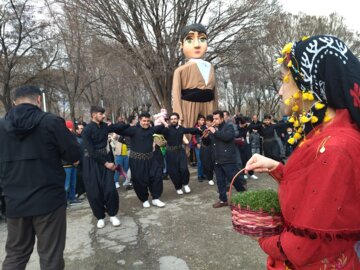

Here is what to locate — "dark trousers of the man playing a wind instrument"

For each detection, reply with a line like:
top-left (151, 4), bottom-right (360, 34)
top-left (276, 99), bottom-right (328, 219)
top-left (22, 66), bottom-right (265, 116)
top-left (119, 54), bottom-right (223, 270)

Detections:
top-left (214, 163), bottom-right (246, 202)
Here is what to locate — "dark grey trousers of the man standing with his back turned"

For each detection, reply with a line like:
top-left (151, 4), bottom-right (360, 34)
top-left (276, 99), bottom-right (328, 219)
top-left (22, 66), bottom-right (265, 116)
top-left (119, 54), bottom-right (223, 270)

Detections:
top-left (2, 205), bottom-right (66, 270)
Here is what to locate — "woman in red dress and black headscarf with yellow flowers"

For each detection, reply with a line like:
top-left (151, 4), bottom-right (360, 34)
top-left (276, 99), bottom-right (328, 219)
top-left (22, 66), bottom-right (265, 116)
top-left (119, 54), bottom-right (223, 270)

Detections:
top-left (246, 36), bottom-right (360, 270)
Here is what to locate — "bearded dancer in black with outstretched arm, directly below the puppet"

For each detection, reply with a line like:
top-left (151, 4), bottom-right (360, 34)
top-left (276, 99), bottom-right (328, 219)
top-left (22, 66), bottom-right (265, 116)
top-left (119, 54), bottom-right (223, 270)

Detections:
top-left (163, 112), bottom-right (202, 195)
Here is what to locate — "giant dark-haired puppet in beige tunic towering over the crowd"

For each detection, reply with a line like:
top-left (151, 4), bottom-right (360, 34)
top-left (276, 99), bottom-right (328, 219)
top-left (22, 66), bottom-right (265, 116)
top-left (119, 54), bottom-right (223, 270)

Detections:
top-left (172, 24), bottom-right (217, 127)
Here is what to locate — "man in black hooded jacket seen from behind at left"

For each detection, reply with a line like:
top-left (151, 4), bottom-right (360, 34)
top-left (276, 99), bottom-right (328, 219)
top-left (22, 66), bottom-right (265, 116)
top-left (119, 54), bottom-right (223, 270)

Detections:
top-left (0, 86), bottom-right (80, 270)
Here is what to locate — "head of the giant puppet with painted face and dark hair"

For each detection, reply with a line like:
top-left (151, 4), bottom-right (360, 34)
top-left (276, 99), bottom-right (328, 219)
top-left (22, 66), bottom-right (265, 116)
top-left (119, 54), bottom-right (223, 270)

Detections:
top-left (180, 23), bottom-right (207, 59)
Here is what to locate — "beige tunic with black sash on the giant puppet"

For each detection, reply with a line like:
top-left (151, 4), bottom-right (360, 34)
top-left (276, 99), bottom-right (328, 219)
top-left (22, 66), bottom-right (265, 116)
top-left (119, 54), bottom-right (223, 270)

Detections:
top-left (172, 59), bottom-right (218, 130)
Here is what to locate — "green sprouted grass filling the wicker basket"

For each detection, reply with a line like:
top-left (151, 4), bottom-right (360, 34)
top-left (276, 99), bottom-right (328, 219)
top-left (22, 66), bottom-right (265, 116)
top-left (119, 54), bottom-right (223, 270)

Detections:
top-left (231, 189), bottom-right (281, 213)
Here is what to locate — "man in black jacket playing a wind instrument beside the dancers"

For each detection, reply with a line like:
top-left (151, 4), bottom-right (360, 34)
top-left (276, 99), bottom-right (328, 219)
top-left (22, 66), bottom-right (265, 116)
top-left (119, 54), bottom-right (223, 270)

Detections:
top-left (203, 111), bottom-right (246, 208)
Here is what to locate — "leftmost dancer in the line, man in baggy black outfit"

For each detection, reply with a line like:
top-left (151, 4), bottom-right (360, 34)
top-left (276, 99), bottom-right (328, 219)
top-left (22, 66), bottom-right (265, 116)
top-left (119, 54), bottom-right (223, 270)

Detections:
top-left (82, 106), bottom-right (129, 229)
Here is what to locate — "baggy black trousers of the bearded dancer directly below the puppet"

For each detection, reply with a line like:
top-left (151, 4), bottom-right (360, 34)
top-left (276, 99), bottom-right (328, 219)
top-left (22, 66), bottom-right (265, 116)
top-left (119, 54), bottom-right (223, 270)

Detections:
top-left (166, 149), bottom-right (190, 190)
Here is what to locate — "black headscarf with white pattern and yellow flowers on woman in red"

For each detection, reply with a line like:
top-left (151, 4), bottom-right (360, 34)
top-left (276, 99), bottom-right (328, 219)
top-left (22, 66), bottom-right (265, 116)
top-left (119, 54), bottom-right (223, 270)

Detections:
top-left (278, 35), bottom-right (360, 141)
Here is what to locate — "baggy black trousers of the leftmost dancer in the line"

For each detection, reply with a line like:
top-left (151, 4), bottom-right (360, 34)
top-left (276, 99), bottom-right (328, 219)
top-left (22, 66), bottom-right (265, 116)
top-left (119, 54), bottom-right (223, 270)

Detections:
top-left (82, 157), bottom-right (119, 219)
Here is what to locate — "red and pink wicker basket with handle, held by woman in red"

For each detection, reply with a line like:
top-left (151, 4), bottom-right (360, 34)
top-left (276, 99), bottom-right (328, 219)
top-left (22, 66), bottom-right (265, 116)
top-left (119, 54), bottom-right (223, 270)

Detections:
top-left (229, 170), bottom-right (283, 237)
